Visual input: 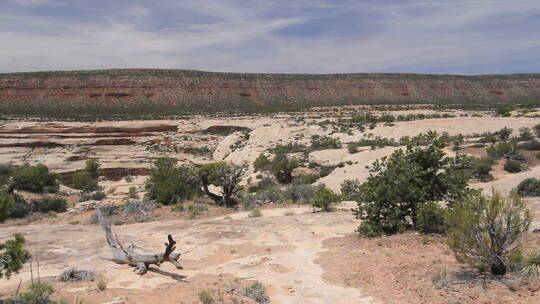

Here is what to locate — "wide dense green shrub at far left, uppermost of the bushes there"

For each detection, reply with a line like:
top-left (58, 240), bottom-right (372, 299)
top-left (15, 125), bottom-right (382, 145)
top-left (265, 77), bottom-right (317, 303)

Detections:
top-left (12, 164), bottom-right (58, 193)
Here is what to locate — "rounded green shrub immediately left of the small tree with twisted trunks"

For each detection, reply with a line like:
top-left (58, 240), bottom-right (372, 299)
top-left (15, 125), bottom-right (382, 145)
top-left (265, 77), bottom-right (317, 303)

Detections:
top-left (146, 157), bottom-right (199, 205)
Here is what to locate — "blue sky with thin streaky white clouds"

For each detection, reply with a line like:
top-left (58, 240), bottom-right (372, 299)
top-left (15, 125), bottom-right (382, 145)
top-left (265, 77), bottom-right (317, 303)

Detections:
top-left (0, 0), bottom-right (540, 75)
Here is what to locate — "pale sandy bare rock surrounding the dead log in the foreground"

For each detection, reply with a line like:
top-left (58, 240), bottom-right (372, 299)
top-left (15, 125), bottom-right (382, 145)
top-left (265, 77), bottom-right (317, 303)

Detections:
top-left (0, 205), bottom-right (370, 303)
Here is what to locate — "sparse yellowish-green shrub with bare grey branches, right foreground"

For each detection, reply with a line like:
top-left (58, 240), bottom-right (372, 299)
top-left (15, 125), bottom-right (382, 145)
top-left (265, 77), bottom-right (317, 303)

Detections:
top-left (447, 192), bottom-right (532, 275)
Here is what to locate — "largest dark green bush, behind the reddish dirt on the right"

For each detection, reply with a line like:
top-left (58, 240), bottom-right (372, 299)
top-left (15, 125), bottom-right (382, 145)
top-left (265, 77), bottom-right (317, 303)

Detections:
top-left (354, 141), bottom-right (475, 237)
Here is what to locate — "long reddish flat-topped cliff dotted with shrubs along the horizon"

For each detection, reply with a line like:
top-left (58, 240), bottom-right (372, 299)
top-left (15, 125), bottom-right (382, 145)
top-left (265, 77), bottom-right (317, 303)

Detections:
top-left (0, 70), bottom-right (540, 113)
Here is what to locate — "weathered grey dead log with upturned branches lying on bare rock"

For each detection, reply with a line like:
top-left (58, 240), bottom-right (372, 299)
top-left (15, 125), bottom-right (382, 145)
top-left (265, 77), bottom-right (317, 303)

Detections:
top-left (96, 208), bottom-right (183, 275)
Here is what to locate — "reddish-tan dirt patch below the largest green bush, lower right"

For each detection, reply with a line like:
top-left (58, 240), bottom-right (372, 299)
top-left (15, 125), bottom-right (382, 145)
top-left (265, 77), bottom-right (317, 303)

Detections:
top-left (316, 233), bottom-right (540, 304)
